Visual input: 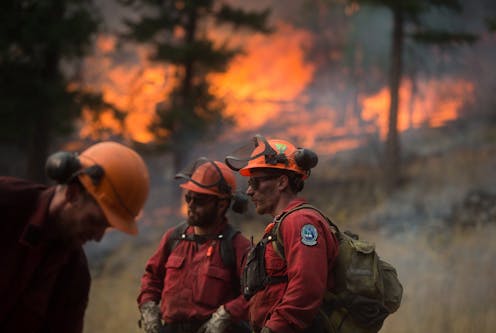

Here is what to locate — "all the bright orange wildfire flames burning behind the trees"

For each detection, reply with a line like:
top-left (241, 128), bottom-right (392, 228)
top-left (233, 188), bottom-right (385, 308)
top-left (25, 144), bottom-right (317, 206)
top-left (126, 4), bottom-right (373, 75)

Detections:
top-left (80, 23), bottom-right (474, 154)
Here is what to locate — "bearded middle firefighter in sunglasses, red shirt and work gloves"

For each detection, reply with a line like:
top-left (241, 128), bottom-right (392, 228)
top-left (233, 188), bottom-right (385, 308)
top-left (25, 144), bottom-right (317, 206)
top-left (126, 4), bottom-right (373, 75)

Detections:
top-left (137, 158), bottom-right (250, 333)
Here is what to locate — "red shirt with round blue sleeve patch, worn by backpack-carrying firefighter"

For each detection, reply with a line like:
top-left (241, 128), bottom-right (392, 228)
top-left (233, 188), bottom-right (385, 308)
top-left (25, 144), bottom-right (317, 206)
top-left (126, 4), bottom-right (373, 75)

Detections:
top-left (249, 199), bottom-right (338, 333)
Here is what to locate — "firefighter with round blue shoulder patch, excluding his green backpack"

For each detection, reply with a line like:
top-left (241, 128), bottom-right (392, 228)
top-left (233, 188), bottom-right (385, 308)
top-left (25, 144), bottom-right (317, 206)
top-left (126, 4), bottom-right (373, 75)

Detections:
top-left (226, 135), bottom-right (338, 333)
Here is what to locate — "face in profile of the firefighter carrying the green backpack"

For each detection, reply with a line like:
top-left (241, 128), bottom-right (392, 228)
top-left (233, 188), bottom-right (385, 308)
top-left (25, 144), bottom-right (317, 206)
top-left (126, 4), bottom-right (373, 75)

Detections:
top-left (246, 170), bottom-right (280, 215)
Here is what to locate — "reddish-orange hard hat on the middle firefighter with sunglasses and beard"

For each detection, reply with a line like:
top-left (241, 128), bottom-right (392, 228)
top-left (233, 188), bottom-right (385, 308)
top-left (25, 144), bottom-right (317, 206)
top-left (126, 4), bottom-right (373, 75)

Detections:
top-left (176, 157), bottom-right (236, 198)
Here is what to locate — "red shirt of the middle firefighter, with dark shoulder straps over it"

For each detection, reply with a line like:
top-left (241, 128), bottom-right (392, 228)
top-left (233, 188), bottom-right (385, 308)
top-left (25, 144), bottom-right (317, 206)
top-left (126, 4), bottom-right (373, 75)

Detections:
top-left (138, 221), bottom-right (250, 323)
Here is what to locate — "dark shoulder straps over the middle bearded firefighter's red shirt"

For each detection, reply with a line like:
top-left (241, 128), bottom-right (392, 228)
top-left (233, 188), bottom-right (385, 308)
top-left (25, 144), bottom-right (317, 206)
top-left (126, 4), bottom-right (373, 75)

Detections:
top-left (165, 222), bottom-right (240, 268)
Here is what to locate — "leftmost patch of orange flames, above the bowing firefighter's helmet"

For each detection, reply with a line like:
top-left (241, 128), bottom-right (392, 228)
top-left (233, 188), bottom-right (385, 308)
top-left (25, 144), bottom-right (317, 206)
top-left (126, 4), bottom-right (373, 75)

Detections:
top-left (80, 36), bottom-right (174, 142)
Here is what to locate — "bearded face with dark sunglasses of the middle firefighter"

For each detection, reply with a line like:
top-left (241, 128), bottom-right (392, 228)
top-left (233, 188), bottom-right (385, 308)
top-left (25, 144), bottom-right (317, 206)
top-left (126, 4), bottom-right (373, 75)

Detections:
top-left (185, 191), bottom-right (219, 227)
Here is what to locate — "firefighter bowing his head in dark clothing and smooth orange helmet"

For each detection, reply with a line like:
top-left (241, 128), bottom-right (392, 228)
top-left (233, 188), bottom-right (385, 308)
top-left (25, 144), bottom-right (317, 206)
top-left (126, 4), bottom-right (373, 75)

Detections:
top-left (0, 142), bottom-right (149, 333)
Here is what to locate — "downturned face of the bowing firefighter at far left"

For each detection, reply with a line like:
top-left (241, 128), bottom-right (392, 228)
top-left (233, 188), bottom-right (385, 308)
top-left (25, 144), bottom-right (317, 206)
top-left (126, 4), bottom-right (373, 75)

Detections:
top-left (59, 191), bottom-right (110, 245)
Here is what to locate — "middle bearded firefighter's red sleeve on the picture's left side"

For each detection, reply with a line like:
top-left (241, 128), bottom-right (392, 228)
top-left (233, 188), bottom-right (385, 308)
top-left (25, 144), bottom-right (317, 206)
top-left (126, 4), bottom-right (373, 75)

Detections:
top-left (137, 229), bottom-right (173, 305)
